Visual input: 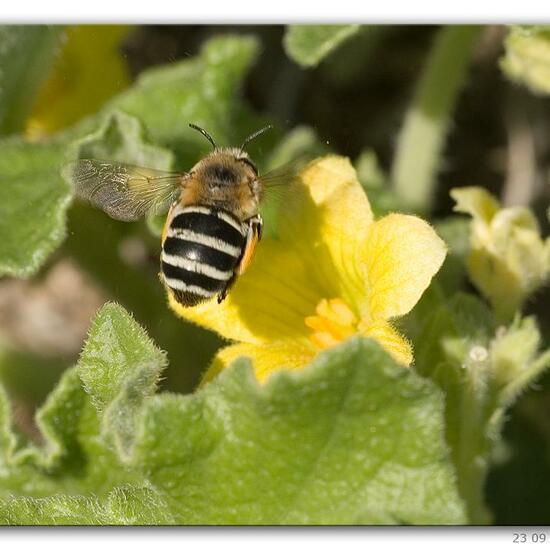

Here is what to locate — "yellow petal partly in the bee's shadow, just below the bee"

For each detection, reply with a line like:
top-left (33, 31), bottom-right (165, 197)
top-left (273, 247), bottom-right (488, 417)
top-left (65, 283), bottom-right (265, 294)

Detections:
top-left (169, 239), bottom-right (322, 344)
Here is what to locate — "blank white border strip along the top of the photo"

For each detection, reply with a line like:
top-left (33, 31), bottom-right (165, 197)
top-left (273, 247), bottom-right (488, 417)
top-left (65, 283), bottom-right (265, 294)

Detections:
top-left (0, 0), bottom-right (550, 24)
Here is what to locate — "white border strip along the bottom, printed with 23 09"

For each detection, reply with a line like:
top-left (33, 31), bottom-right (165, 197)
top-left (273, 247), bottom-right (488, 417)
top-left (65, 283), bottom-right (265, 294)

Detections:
top-left (0, 527), bottom-right (550, 550)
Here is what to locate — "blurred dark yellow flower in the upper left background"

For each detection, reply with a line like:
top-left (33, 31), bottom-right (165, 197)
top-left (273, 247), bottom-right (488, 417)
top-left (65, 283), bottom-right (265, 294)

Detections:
top-left (26, 25), bottom-right (131, 139)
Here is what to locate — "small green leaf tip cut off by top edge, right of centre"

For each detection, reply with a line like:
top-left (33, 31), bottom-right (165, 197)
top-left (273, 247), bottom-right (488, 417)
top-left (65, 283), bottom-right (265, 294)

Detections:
top-left (284, 25), bottom-right (361, 67)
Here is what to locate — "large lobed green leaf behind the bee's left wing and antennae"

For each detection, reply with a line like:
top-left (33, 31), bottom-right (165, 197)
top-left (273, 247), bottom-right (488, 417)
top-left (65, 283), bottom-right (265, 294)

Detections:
top-left (0, 36), bottom-right (263, 284)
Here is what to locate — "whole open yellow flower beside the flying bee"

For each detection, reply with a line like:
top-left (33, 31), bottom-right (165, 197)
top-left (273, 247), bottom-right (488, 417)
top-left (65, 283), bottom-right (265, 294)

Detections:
top-left (170, 156), bottom-right (446, 380)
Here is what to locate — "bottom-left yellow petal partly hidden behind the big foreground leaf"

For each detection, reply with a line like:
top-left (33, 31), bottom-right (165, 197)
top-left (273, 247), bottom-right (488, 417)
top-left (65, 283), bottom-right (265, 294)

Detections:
top-left (201, 340), bottom-right (316, 384)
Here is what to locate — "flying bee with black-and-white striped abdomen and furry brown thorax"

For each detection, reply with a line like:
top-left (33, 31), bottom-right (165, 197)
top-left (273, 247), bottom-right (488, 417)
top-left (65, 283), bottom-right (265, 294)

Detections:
top-left (64, 124), bottom-right (282, 307)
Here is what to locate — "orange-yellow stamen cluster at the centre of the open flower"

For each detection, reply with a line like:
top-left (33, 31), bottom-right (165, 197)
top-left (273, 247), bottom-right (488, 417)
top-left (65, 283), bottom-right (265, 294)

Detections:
top-left (305, 298), bottom-right (358, 349)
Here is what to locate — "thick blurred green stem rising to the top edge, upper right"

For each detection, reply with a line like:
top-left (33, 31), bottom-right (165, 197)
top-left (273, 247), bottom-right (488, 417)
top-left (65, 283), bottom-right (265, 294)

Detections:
top-left (391, 25), bottom-right (483, 213)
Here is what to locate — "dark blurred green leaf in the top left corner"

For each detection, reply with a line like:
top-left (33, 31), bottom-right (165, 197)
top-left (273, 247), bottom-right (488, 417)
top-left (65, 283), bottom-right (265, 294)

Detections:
top-left (0, 25), bottom-right (64, 134)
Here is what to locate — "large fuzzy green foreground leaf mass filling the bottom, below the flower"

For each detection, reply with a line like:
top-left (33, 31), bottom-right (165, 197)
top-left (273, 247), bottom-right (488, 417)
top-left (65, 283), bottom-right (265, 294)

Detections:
top-left (0, 304), bottom-right (465, 524)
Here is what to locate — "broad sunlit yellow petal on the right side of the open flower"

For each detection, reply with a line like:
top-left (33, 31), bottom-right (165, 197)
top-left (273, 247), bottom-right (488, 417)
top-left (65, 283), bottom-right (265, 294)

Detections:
top-left (361, 214), bottom-right (446, 320)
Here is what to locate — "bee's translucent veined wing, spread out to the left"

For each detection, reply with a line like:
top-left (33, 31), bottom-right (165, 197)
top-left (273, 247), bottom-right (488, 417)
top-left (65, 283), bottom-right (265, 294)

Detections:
top-left (63, 159), bottom-right (189, 221)
